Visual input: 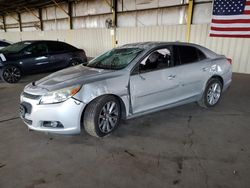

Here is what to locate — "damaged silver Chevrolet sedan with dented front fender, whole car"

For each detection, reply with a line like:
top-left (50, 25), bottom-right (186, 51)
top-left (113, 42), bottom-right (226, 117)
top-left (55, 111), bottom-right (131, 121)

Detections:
top-left (20, 42), bottom-right (232, 137)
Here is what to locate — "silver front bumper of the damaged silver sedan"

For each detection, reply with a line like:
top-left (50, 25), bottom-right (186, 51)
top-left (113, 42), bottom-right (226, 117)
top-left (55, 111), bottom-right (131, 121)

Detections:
top-left (21, 96), bottom-right (85, 134)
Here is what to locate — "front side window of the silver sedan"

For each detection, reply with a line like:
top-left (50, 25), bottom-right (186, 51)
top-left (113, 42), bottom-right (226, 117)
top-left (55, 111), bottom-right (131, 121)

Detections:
top-left (139, 48), bottom-right (171, 73)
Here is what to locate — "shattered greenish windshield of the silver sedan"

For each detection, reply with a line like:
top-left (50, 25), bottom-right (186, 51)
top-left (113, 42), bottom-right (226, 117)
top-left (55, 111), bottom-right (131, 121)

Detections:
top-left (87, 48), bottom-right (142, 70)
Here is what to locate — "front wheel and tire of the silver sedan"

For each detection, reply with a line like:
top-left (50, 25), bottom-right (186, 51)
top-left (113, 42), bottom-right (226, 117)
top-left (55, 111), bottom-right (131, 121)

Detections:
top-left (83, 95), bottom-right (121, 137)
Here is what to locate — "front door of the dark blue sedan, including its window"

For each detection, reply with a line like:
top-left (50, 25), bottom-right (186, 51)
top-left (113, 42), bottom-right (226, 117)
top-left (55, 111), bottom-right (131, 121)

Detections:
top-left (20, 42), bottom-right (50, 73)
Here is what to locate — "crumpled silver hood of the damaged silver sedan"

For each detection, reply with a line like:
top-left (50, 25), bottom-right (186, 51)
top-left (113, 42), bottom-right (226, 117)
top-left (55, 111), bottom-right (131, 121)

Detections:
top-left (24, 65), bottom-right (120, 95)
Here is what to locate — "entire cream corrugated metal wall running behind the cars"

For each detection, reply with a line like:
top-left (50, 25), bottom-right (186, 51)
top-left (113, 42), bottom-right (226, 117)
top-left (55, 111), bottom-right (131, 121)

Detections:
top-left (0, 24), bottom-right (250, 73)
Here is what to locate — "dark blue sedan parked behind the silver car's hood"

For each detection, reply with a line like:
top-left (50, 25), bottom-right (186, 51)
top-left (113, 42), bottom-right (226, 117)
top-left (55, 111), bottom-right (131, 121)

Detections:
top-left (0, 40), bottom-right (87, 83)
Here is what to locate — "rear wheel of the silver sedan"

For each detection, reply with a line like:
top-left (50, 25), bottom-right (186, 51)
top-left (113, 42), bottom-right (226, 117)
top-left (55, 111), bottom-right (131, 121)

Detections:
top-left (198, 78), bottom-right (222, 108)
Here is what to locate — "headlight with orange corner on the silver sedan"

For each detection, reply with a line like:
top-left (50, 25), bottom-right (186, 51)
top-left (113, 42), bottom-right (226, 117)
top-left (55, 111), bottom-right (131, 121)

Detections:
top-left (39, 85), bottom-right (81, 104)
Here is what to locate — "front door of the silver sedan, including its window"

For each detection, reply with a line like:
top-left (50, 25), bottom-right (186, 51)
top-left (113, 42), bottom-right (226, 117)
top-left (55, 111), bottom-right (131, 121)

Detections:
top-left (130, 47), bottom-right (179, 114)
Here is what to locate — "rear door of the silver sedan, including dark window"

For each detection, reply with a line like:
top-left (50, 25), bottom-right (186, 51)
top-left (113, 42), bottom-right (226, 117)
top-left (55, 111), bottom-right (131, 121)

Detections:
top-left (173, 45), bottom-right (211, 100)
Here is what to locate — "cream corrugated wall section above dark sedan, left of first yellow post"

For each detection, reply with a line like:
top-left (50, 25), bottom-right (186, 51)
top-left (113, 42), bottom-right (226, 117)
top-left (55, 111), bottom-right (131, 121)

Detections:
top-left (0, 28), bottom-right (112, 57)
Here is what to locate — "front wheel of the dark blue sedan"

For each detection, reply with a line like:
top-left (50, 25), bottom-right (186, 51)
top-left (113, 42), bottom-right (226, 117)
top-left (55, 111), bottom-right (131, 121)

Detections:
top-left (1, 65), bottom-right (22, 84)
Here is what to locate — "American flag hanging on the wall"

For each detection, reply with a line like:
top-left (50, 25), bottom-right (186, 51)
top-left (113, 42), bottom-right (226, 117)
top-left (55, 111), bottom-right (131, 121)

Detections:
top-left (210, 0), bottom-right (250, 38)
